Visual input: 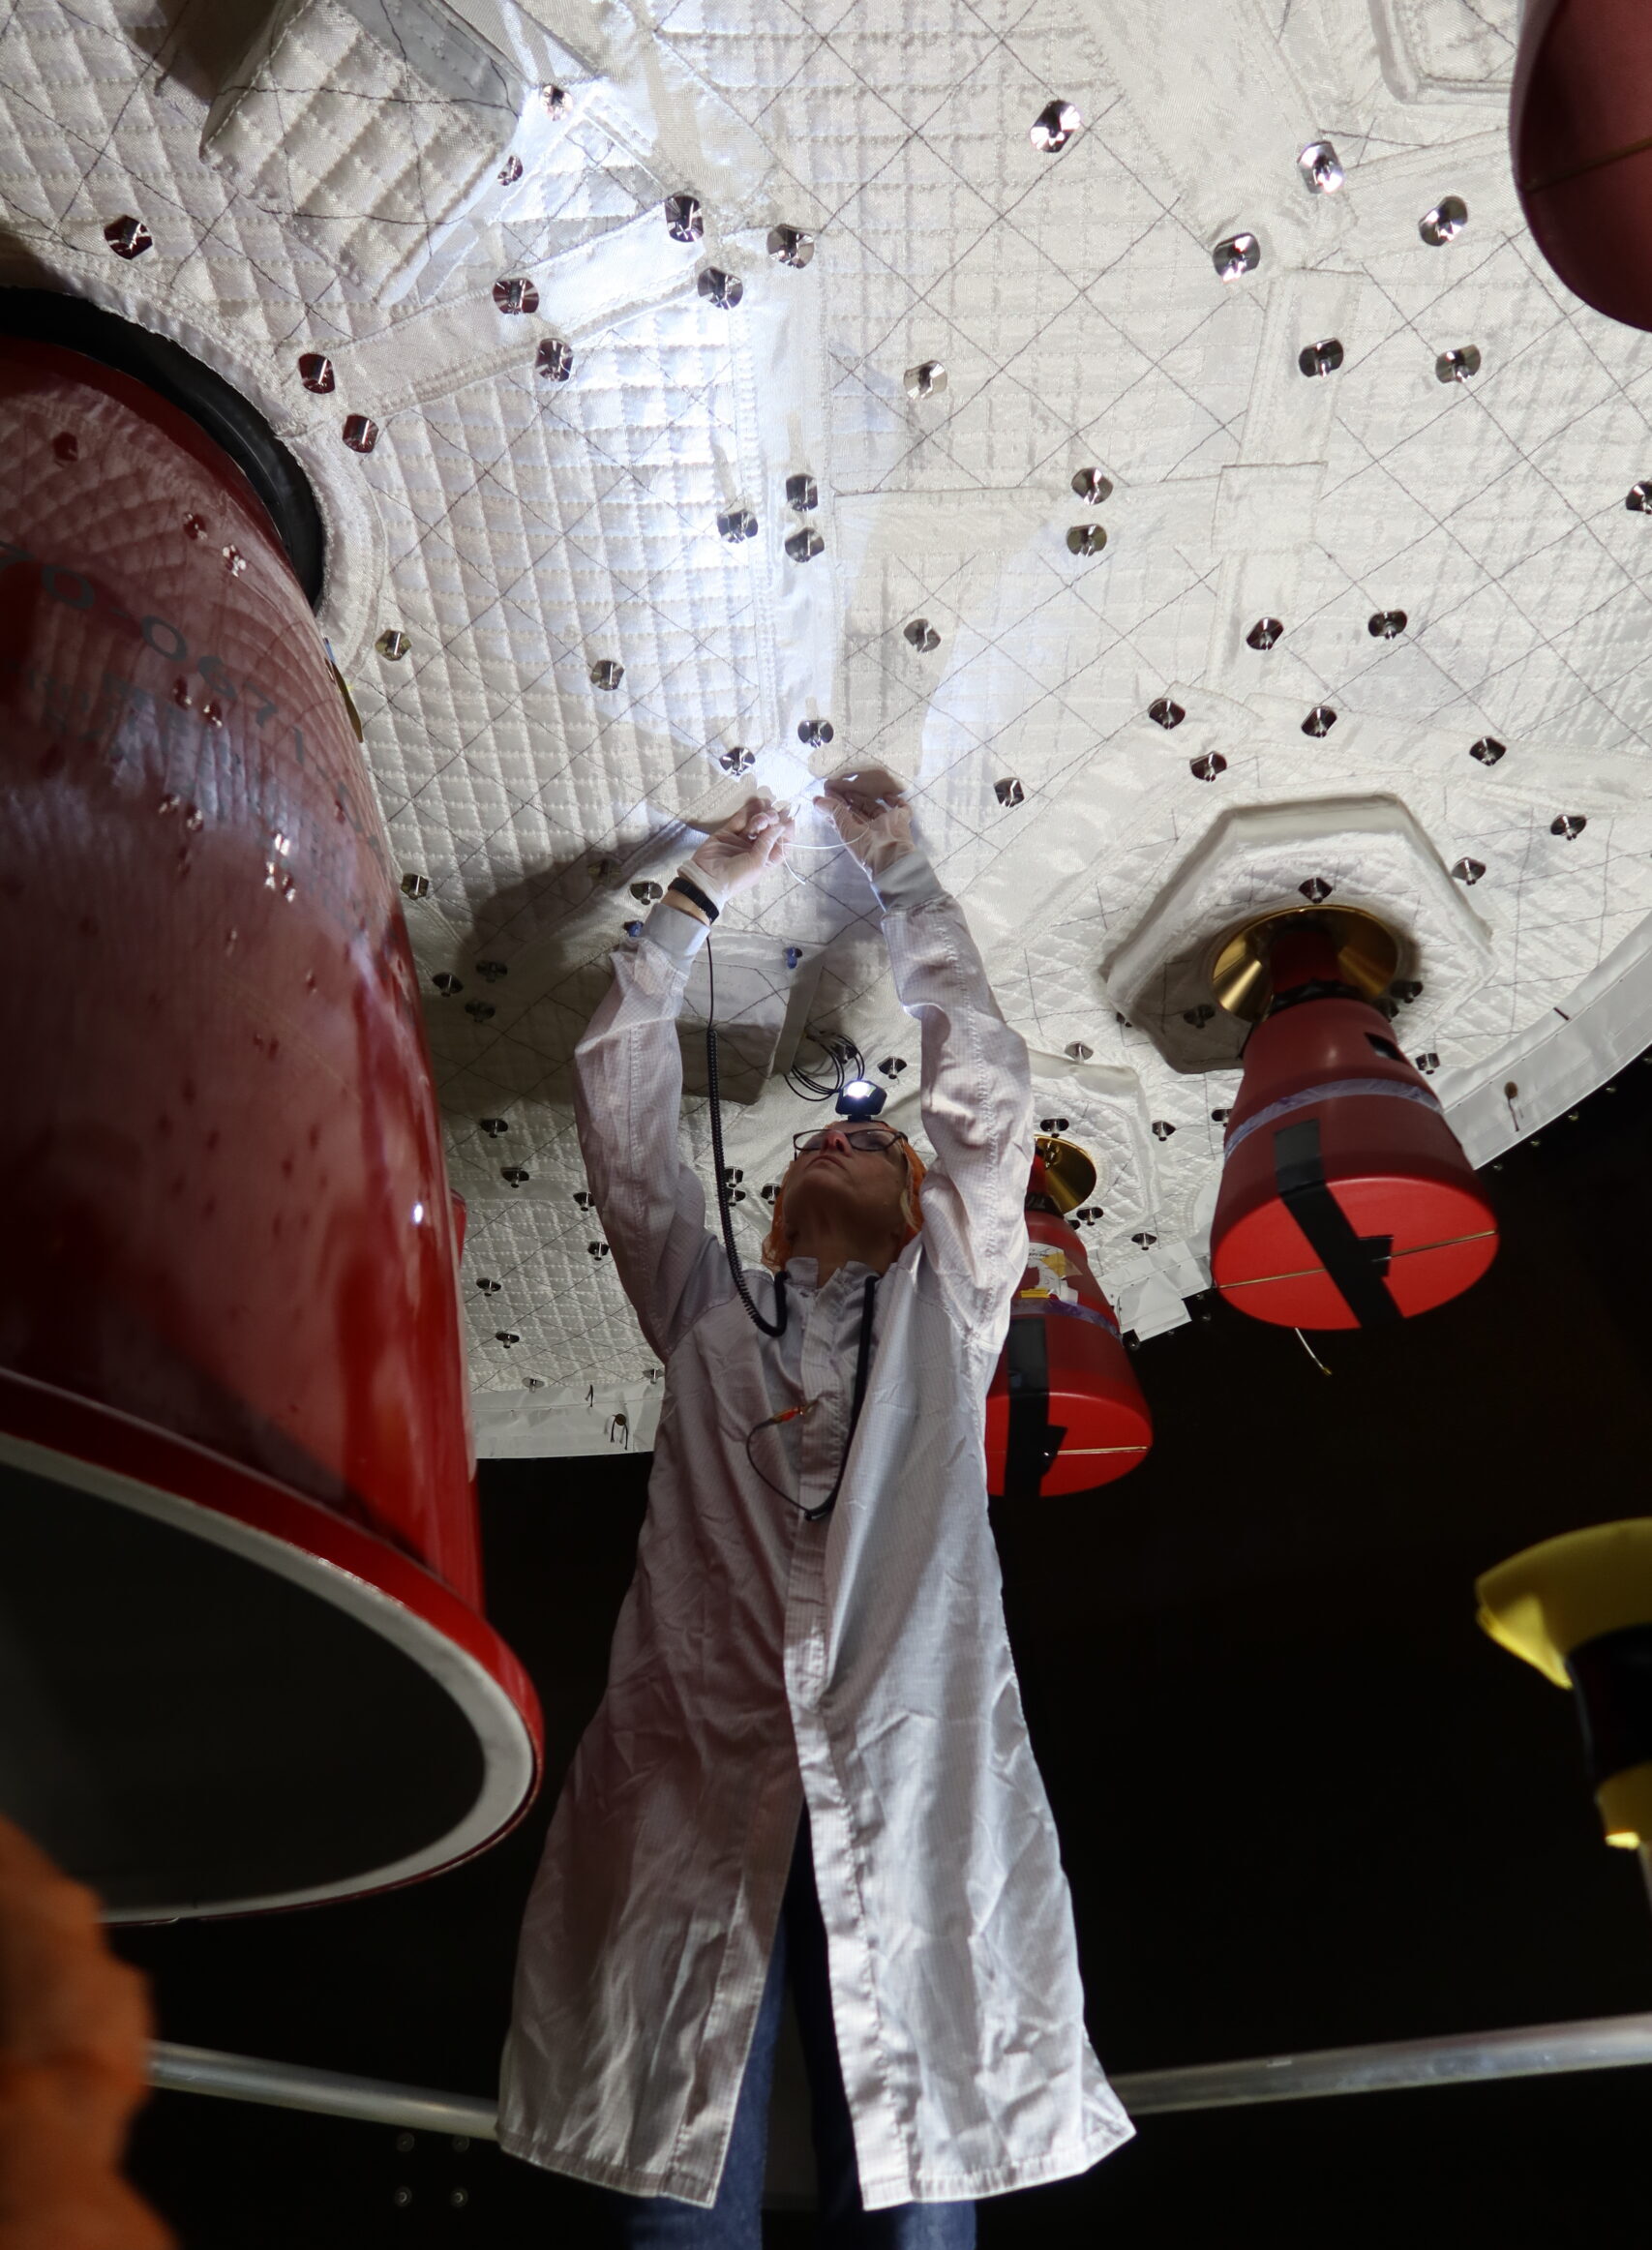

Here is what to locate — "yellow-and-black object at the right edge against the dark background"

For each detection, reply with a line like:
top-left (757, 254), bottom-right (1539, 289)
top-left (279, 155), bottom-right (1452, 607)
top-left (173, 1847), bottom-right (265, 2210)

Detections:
top-left (1474, 1516), bottom-right (1652, 1849)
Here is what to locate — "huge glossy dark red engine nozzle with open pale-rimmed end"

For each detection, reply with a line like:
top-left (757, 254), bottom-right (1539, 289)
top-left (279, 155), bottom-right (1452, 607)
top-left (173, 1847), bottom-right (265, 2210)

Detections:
top-left (0, 309), bottom-right (540, 1919)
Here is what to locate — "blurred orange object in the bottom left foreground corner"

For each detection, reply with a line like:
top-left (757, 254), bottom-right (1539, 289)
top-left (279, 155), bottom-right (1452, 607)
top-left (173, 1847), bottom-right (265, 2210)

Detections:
top-left (0, 1820), bottom-right (173, 2250)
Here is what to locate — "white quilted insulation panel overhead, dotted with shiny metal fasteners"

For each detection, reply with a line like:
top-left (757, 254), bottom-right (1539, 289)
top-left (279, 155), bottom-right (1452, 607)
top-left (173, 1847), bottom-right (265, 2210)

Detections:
top-left (0, 0), bottom-right (1652, 1454)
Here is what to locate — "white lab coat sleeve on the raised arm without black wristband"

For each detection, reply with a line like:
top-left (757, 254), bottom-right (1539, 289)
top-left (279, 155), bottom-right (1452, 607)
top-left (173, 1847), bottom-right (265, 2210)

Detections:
top-left (878, 851), bottom-right (1033, 1328)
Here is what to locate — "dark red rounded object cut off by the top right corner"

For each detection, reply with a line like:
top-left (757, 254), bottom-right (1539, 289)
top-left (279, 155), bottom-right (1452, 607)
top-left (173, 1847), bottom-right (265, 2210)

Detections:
top-left (1508, 0), bottom-right (1652, 328)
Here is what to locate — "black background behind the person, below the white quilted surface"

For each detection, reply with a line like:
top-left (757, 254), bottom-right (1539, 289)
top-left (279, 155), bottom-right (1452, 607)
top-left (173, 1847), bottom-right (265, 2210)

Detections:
top-left (117, 1066), bottom-right (1652, 2250)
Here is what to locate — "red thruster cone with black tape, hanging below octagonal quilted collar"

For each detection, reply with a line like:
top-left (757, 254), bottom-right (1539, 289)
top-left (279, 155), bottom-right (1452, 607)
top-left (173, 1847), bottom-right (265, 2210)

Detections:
top-left (1211, 927), bottom-right (1497, 1328)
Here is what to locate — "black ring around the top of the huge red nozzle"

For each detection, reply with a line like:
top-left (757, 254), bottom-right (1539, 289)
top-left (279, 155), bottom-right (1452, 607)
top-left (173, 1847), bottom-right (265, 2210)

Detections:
top-left (0, 288), bottom-right (326, 610)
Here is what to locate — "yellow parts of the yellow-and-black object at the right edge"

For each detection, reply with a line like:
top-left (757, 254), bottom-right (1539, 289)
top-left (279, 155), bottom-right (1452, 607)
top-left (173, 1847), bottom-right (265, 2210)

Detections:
top-left (1474, 1516), bottom-right (1652, 1849)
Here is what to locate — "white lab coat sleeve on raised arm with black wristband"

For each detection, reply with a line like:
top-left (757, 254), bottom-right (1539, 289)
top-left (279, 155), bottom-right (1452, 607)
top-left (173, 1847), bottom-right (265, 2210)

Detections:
top-left (574, 902), bottom-right (727, 1362)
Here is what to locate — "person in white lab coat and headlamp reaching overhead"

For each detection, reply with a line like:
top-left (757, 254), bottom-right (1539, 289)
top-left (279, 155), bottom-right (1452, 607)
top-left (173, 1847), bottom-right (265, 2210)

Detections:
top-left (499, 776), bottom-right (1132, 2250)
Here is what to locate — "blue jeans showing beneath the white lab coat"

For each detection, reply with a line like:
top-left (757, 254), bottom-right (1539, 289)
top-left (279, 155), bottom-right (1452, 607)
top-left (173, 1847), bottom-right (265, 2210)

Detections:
top-left (601, 1814), bottom-right (975, 2250)
